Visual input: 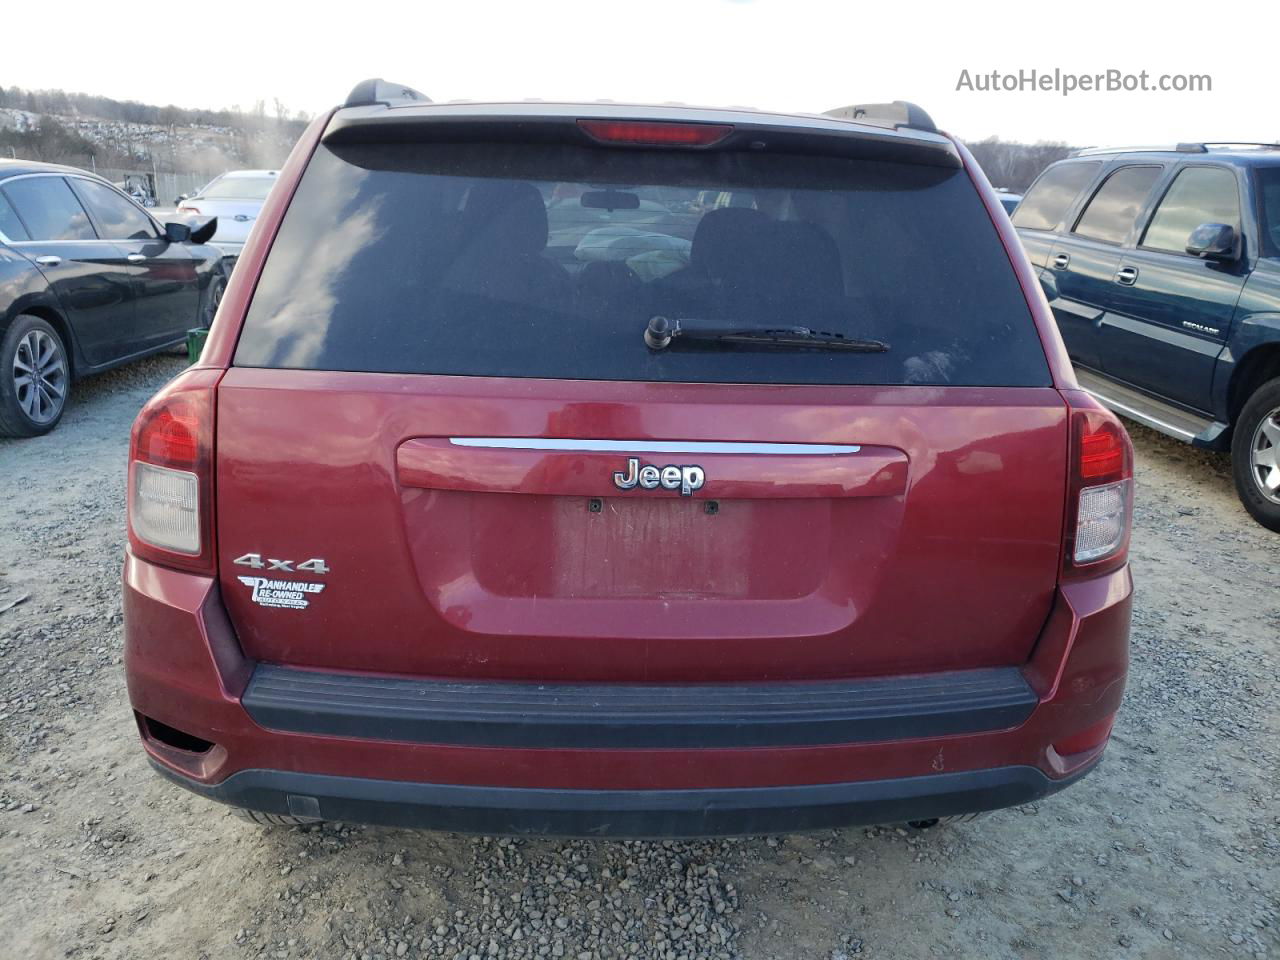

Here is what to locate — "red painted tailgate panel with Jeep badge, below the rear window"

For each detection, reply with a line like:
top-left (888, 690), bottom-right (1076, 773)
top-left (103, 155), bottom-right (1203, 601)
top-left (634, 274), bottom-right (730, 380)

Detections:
top-left (218, 370), bottom-right (1066, 681)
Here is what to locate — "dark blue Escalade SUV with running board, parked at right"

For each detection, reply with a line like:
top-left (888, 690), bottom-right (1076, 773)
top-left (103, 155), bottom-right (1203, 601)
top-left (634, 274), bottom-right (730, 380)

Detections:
top-left (1012, 143), bottom-right (1280, 531)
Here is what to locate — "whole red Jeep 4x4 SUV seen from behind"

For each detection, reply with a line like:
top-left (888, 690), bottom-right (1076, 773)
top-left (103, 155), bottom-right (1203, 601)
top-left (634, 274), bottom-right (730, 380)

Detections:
top-left (124, 81), bottom-right (1133, 837)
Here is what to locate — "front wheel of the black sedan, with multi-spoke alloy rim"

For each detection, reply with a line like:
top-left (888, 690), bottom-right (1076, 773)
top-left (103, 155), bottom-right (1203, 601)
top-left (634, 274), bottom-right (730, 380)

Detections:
top-left (0, 314), bottom-right (72, 436)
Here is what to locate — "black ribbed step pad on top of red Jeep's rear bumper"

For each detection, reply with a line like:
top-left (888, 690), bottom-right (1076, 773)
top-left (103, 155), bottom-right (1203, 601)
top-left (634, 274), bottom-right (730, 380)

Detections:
top-left (243, 664), bottom-right (1038, 749)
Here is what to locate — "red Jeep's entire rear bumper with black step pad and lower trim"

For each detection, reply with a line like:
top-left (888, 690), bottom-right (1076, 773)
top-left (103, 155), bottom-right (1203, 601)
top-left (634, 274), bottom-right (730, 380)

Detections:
top-left (124, 556), bottom-right (1132, 836)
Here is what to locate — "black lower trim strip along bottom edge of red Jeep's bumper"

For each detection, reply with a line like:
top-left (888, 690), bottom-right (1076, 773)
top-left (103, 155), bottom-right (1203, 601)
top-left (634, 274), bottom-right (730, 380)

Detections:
top-left (152, 762), bottom-right (1092, 838)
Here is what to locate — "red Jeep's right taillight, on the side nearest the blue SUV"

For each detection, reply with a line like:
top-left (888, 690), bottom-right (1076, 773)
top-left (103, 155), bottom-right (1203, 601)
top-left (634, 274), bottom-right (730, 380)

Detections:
top-left (1064, 399), bottom-right (1133, 576)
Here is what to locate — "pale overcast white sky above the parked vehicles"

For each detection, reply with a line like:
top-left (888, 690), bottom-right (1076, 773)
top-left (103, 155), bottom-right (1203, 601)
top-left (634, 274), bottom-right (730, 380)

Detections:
top-left (0, 0), bottom-right (1280, 146)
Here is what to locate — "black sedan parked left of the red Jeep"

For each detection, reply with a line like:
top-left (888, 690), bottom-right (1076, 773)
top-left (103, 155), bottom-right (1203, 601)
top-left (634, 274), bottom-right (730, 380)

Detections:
top-left (0, 160), bottom-right (227, 436)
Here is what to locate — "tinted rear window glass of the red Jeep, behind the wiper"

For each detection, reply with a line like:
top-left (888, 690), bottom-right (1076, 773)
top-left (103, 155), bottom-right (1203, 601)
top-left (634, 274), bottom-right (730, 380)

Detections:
top-left (236, 143), bottom-right (1050, 385)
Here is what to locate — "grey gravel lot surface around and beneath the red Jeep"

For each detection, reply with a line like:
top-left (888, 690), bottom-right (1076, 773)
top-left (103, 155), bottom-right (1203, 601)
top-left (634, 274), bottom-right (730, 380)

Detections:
top-left (0, 358), bottom-right (1280, 960)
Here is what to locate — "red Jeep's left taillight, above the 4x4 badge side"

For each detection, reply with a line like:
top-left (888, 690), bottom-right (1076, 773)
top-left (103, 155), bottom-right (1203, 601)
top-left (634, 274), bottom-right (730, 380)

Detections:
top-left (128, 370), bottom-right (221, 573)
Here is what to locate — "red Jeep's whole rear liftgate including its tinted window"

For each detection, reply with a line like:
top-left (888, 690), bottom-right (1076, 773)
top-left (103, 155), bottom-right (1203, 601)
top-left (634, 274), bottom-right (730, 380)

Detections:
top-left (216, 108), bottom-right (1068, 682)
